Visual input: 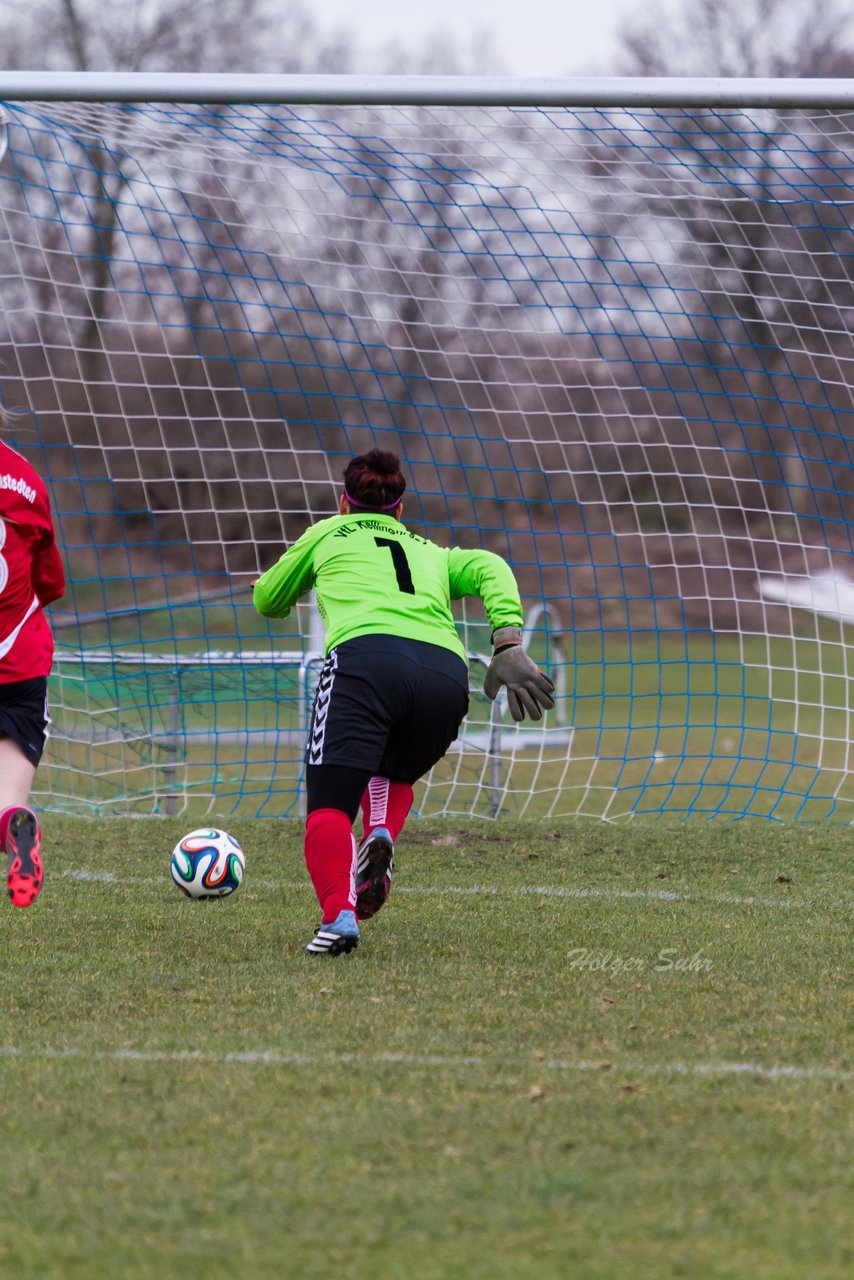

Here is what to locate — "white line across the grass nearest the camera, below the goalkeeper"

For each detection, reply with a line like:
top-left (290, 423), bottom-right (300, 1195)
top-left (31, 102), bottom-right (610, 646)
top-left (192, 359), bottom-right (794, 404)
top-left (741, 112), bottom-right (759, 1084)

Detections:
top-left (0, 1044), bottom-right (854, 1083)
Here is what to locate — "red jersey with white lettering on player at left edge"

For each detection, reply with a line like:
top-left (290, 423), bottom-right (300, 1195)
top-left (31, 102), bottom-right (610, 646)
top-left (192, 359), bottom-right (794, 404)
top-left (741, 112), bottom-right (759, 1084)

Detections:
top-left (0, 440), bottom-right (65, 685)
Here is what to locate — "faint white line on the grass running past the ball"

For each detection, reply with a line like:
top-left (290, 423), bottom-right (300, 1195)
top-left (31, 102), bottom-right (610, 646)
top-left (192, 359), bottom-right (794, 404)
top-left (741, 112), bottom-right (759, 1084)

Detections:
top-left (55, 868), bottom-right (809, 906)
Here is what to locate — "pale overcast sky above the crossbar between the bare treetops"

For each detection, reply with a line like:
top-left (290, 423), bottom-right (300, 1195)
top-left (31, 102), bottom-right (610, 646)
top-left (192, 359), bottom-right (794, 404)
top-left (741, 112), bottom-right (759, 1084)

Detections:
top-left (310, 0), bottom-right (647, 76)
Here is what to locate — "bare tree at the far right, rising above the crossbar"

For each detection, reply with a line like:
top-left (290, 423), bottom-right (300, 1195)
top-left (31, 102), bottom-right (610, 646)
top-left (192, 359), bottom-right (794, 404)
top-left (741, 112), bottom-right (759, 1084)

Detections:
top-left (595, 0), bottom-right (854, 552)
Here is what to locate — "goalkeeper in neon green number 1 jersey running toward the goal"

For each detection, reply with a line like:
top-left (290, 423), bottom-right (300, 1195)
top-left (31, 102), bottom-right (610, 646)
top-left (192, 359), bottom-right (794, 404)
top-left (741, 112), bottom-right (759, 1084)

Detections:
top-left (255, 449), bottom-right (554, 955)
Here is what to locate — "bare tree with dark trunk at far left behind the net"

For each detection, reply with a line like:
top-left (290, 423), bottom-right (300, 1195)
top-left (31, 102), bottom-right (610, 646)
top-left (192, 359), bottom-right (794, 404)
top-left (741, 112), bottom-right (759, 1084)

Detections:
top-left (0, 0), bottom-right (363, 588)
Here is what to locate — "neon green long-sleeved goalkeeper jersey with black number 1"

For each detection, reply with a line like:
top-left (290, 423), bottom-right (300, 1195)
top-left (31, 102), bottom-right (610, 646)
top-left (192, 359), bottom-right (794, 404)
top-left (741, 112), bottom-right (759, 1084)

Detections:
top-left (255, 512), bottom-right (522, 659)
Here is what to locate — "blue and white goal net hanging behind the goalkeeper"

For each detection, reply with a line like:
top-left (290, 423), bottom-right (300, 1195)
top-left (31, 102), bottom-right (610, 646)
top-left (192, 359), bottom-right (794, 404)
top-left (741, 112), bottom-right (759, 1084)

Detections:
top-left (0, 82), bottom-right (854, 820)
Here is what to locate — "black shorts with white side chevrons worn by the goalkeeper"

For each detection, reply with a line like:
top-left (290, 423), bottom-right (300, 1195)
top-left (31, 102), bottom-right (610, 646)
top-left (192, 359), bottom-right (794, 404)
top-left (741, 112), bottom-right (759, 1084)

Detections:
top-left (305, 635), bottom-right (469, 783)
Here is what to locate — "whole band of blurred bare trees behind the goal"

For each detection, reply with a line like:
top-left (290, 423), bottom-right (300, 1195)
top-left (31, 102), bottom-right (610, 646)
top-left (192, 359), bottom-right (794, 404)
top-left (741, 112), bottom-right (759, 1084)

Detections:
top-left (0, 0), bottom-right (854, 625)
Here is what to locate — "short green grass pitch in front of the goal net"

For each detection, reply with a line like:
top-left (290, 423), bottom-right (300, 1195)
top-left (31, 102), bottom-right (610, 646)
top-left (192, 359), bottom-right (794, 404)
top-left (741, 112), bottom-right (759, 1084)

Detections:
top-left (0, 815), bottom-right (854, 1280)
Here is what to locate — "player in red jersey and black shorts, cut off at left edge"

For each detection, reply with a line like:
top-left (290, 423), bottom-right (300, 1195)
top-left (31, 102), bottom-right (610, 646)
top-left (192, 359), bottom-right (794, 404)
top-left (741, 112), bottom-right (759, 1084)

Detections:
top-left (0, 424), bottom-right (65, 906)
